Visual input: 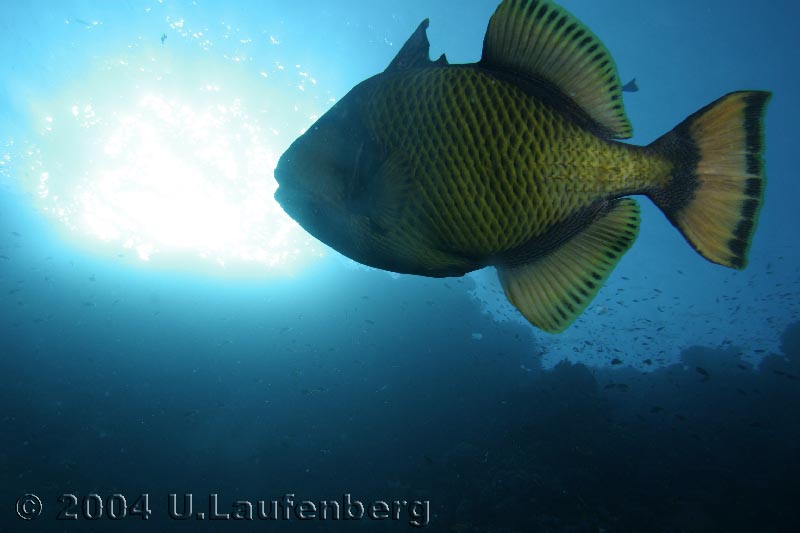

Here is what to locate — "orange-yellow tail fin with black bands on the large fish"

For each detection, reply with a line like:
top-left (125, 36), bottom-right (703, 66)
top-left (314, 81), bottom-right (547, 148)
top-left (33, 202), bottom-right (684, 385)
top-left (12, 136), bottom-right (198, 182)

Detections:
top-left (648, 91), bottom-right (771, 269)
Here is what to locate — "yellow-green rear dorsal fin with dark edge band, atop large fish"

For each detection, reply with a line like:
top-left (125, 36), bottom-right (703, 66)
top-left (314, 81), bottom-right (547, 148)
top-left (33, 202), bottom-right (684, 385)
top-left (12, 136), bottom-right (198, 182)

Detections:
top-left (481, 0), bottom-right (633, 139)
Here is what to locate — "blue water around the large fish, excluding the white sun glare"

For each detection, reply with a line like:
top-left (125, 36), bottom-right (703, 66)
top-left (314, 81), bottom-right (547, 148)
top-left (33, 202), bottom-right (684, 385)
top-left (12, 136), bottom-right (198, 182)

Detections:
top-left (0, 0), bottom-right (800, 533)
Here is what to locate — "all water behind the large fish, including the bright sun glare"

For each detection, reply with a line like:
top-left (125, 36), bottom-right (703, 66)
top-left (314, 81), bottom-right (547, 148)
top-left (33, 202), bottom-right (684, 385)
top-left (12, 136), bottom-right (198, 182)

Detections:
top-left (0, 0), bottom-right (800, 533)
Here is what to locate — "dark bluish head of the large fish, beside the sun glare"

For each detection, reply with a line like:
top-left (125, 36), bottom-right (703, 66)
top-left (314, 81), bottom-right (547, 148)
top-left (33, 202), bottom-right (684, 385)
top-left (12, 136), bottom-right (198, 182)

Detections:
top-left (275, 80), bottom-right (383, 260)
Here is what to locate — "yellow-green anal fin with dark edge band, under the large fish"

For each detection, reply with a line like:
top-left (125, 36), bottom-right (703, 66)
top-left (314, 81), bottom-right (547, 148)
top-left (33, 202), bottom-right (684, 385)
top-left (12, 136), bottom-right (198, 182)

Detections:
top-left (497, 198), bottom-right (639, 333)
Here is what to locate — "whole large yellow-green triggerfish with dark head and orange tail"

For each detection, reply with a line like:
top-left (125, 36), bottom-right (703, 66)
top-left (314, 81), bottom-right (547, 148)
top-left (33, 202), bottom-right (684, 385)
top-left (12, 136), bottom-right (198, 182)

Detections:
top-left (275, 0), bottom-right (770, 332)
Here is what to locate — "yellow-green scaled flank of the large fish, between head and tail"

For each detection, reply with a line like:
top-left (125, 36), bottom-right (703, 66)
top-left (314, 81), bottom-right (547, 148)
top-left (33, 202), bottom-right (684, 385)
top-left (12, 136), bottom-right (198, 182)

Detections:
top-left (366, 68), bottom-right (669, 257)
